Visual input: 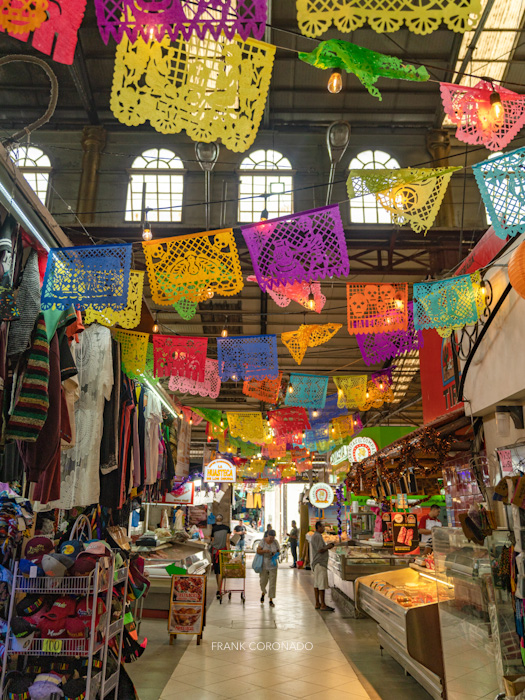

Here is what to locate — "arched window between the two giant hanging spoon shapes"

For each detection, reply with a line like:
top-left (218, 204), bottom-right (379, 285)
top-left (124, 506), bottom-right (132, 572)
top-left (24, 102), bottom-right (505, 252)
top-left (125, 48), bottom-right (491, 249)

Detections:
top-left (239, 149), bottom-right (293, 222)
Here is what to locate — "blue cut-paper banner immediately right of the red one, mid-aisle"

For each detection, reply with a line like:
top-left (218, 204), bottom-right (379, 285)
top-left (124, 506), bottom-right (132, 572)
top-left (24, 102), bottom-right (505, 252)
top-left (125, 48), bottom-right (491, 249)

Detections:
top-left (217, 335), bottom-right (279, 382)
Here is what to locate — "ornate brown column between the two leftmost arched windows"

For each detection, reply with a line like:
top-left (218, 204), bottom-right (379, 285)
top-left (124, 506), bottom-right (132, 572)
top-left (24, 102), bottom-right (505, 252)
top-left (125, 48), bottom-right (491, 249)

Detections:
top-left (77, 126), bottom-right (106, 224)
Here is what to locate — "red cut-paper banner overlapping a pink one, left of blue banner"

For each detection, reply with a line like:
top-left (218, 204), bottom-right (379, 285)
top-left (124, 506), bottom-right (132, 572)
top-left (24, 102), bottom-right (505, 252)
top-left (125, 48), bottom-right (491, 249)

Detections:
top-left (153, 334), bottom-right (208, 382)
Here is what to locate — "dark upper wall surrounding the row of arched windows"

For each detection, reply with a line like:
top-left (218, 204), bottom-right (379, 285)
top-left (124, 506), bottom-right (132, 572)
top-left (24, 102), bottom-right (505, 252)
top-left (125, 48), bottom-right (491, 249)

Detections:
top-left (27, 128), bottom-right (488, 234)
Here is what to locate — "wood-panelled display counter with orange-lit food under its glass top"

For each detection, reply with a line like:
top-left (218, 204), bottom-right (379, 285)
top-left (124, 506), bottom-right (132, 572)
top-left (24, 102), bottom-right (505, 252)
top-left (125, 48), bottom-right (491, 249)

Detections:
top-left (356, 568), bottom-right (445, 699)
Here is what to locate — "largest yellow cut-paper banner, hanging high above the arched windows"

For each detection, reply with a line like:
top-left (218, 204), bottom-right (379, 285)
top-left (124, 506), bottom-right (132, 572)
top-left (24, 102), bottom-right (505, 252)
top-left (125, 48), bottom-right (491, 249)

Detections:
top-left (110, 31), bottom-right (275, 153)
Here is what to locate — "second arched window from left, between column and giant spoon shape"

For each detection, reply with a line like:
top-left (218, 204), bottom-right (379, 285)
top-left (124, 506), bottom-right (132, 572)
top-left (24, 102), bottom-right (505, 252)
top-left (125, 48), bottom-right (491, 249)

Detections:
top-left (126, 148), bottom-right (184, 221)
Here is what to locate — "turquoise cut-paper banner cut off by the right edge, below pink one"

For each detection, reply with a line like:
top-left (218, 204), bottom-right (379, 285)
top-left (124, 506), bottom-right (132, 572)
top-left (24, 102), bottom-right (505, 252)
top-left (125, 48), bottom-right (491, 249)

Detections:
top-left (472, 147), bottom-right (525, 239)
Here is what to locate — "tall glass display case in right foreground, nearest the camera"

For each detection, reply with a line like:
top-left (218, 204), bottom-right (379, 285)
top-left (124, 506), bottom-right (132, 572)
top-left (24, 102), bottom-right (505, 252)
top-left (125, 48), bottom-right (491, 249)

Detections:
top-left (433, 528), bottom-right (524, 700)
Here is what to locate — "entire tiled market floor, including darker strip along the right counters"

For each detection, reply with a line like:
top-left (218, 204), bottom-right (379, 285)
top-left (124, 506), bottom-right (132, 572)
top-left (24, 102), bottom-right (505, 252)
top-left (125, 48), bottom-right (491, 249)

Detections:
top-left (147, 567), bottom-right (429, 700)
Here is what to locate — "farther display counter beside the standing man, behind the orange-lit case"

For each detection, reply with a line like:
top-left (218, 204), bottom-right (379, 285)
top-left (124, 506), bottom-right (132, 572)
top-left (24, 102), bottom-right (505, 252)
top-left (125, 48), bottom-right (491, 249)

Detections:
top-left (328, 546), bottom-right (414, 601)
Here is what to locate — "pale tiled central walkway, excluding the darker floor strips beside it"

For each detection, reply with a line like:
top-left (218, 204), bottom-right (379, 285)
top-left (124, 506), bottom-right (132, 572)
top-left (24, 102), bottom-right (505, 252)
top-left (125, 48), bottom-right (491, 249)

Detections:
top-left (161, 567), bottom-right (368, 700)
